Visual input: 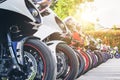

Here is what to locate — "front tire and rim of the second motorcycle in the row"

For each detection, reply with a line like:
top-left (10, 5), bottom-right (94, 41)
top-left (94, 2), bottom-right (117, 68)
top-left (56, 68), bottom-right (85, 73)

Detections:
top-left (56, 43), bottom-right (79, 80)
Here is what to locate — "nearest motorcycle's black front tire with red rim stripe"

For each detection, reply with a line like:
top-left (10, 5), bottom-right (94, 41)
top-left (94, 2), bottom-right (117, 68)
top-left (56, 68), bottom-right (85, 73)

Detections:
top-left (24, 39), bottom-right (57, 80)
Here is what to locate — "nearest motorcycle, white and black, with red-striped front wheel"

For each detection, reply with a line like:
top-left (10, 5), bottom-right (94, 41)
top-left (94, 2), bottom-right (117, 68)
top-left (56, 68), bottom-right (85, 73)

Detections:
top-left (0, 0), bottom-right (56, 80)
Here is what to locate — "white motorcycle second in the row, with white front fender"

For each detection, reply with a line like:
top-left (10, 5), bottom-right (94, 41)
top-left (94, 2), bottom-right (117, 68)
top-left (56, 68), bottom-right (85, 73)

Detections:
top-left (34, 8), bottom-right (79, 80)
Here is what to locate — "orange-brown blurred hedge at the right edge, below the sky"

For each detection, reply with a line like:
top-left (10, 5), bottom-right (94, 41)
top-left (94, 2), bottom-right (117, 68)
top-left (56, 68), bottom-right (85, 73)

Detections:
top-left (86, 30), bottom-right (120, 50)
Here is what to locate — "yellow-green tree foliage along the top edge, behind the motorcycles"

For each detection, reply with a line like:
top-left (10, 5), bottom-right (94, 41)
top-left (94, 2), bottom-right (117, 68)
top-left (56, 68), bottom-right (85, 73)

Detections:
top-left (51, 0), bottom-right (94, 19)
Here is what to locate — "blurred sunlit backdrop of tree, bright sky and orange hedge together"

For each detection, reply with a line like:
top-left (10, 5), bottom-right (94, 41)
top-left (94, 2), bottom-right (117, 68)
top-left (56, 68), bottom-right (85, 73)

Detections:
top-left (51, 0), bottom-right (120, 50)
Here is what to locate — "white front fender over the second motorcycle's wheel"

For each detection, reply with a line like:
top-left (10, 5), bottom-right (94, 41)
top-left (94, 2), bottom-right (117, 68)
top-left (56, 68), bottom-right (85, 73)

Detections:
top-left (46, 40), bottom-right (65, 63)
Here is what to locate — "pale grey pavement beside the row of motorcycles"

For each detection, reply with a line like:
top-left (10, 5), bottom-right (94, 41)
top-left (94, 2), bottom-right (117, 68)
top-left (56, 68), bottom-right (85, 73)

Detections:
top-left (76, 58), bottom-right (120, 80)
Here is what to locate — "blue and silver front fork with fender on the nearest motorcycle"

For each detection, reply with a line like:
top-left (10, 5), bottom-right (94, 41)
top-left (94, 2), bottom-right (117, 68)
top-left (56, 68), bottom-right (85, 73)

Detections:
top-left (7, 33), bottom-right (39, 70)
